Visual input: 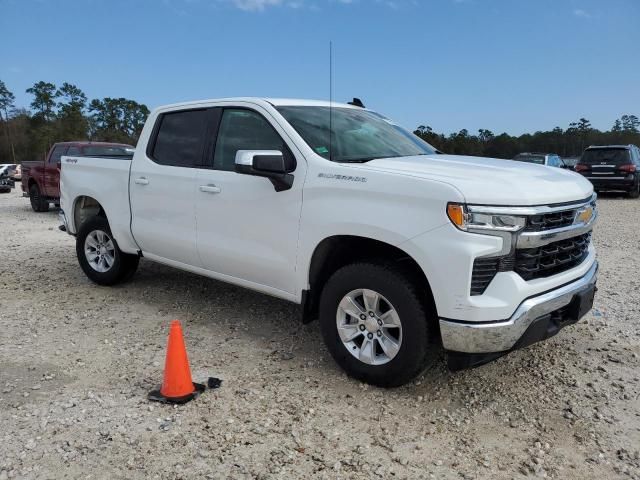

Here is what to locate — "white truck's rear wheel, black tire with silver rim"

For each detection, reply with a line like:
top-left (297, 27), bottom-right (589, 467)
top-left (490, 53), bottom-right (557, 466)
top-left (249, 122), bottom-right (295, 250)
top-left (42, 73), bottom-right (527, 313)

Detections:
top-left (76, 216), bottom-right (139, 285)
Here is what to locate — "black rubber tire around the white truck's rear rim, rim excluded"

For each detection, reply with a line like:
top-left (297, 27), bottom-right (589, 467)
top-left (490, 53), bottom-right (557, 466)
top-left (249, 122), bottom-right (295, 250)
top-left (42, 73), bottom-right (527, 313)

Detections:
top-left (76, 216), bottom-right (140, 285)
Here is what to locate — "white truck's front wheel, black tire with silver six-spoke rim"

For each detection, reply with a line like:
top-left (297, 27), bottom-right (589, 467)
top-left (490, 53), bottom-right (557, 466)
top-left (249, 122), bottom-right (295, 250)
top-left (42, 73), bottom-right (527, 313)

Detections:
top-left (320, 263), bottom-right (438, 387)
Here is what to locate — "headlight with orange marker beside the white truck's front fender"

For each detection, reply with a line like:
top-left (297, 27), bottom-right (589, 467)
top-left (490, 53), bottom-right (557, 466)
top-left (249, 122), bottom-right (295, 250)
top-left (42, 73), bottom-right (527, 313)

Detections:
top-left (447, 203), bottom-right (526, 234)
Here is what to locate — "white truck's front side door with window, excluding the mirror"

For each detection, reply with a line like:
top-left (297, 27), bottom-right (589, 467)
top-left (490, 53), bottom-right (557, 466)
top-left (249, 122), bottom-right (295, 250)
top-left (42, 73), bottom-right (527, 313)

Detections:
top-left (195, 107), bottom-right (306, 293)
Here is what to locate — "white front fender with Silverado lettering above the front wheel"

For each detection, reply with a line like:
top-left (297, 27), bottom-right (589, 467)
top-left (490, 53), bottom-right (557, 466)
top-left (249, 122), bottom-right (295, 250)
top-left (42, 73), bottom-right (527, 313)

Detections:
top-left (297, 161), bottom-right (464, 291)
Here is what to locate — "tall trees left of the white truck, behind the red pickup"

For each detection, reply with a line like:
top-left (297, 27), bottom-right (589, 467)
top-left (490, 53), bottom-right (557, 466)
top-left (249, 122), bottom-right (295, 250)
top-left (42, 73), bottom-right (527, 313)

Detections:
top-left (0, 80), bottom-right (149, 163)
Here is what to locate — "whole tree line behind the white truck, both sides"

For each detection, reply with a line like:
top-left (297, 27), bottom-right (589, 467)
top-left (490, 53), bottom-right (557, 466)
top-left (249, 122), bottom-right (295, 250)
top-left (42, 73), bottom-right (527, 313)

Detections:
top-left (0, 80), bottom-right (640, 163)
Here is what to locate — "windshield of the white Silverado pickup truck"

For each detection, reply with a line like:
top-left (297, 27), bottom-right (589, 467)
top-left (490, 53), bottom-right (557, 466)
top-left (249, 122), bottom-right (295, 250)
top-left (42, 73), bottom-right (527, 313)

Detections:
top-left (278, 106), bottom-right (436, 162)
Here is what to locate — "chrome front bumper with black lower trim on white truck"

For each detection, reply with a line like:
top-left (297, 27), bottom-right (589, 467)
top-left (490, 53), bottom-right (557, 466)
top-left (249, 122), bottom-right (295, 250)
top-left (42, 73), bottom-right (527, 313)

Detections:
top-left (440, 262), bottom-right (598, 370)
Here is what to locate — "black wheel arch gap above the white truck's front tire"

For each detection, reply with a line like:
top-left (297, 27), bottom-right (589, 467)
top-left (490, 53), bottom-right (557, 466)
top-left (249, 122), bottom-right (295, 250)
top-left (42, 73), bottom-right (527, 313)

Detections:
top-left (302, 235), bottom-right (438, 331)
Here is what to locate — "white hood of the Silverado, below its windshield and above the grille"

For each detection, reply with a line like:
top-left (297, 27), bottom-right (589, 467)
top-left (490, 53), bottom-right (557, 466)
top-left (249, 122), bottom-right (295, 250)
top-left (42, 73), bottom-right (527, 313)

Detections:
top-left (362, 154), bottom-right (593, 206)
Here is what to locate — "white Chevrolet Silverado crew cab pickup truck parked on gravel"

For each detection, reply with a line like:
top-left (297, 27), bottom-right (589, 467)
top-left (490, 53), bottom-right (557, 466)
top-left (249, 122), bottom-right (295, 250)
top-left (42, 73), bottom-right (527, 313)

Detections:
top-left (61, 98), bottom-right (597, 386)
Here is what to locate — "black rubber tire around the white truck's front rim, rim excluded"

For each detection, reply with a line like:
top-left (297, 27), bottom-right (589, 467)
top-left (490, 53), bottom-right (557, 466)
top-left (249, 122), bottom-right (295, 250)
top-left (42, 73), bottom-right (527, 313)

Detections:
top-left (320, 263), bottom-right (439, 387)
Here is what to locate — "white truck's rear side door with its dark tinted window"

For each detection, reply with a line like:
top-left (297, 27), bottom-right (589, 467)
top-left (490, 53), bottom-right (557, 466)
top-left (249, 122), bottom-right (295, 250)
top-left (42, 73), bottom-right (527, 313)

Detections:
top-left (129, 109), bottom-right (214, 267)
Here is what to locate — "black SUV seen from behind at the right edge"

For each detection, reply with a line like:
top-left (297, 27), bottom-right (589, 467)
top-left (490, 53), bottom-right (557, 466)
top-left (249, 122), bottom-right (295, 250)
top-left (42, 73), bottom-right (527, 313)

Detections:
top-left (575, 145), bottom-right (640, 198)
